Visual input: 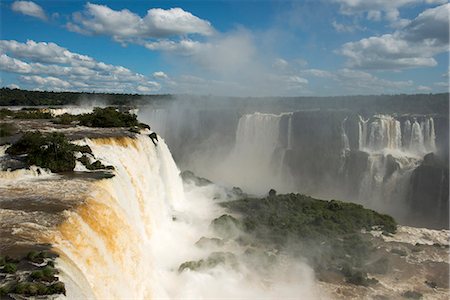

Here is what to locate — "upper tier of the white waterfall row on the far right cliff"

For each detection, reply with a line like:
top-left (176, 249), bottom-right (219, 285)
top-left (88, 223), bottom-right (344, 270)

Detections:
top-left (358, 115), bottom-right (436, 155)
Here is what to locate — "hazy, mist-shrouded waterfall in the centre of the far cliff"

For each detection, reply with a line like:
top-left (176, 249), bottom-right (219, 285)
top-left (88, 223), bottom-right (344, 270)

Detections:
top-left (220, 112), bottom-right (292, 194)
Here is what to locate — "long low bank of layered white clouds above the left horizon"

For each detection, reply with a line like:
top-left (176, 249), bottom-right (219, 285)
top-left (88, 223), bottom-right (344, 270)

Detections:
top-left (0, 40), bottom-right (160, 93)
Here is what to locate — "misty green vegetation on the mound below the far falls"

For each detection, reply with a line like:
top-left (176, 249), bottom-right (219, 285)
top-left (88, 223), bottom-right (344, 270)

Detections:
top-left (218, 191), bottom-right (397, 286)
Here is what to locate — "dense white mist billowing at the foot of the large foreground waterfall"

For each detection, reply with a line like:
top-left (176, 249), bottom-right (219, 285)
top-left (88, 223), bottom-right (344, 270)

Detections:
top-left (149, 182), bottom-right (328, 299)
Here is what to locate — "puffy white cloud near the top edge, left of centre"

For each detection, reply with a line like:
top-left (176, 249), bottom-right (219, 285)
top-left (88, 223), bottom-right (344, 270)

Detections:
top-left (67, 3), bottom-right (214, 42)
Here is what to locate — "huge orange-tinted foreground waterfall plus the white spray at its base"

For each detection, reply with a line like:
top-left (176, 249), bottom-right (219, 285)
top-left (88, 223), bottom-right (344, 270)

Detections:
top-left (12, 135), bottom-right (316, 299)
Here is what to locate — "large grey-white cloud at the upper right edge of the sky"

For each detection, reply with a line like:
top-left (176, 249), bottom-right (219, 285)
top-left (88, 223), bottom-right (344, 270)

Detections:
top-left (338, 4), bottom-right (450, 69)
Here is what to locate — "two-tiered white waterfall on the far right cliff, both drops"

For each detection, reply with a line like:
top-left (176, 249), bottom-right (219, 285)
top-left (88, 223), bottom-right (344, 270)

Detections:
top-left (352, 115), bottom-right (436, 214)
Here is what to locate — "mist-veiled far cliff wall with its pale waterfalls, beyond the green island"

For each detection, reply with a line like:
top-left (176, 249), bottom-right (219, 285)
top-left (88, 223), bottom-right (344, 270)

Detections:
top-left (138, 96), bottom-right (448, 227)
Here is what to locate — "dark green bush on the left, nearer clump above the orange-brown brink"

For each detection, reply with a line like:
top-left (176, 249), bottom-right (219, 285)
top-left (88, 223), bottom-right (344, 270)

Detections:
top-left (6, 131), bottom-right (114, 173)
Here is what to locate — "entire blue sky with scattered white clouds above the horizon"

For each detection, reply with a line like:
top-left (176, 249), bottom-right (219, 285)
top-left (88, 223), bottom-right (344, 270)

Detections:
top-left (0, 0), bottom-right (450, 96)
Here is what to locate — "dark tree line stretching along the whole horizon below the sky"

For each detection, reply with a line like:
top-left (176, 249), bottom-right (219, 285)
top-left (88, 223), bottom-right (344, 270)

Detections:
top-left (0, 87), bottom-right (449, 114)
